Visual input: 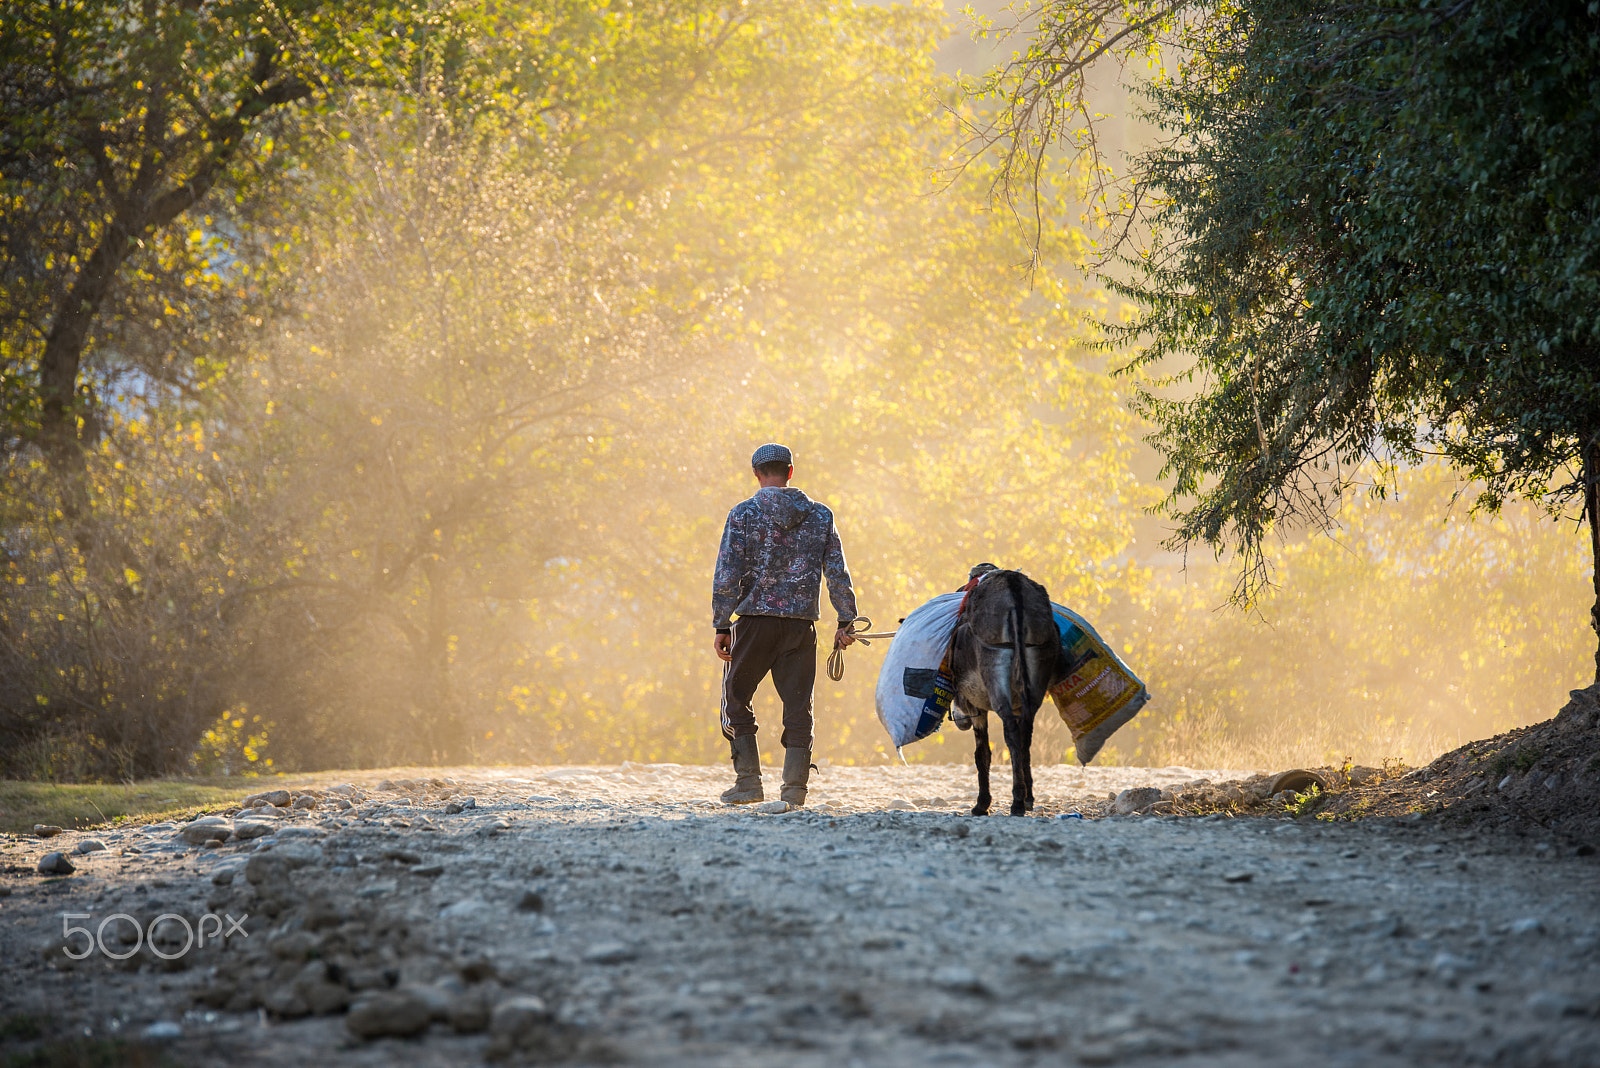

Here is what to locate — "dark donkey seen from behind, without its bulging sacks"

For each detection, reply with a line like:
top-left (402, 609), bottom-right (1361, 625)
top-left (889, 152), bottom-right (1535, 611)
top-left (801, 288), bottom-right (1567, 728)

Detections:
top-left (950, 571), bottom-right (1062, 815)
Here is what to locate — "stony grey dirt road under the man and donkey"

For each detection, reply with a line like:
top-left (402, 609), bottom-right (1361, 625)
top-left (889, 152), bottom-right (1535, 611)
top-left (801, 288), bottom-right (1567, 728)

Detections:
top-left (0, 766), bottom-right (1600, 1068)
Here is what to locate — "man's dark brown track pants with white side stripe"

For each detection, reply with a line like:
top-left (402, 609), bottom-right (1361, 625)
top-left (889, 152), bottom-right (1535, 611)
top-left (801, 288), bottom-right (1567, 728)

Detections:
top-left (722, 616), bottom-right (816, 750)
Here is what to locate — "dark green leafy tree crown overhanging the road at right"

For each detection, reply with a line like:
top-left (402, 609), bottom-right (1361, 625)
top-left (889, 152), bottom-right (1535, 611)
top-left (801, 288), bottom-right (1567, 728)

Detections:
top-left (966, 0), bottom-right (1600, 678)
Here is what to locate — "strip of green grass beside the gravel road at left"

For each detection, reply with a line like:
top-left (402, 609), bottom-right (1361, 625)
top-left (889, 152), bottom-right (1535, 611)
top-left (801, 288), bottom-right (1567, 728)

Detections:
top-left (0, 779), bottom-right (278, 835)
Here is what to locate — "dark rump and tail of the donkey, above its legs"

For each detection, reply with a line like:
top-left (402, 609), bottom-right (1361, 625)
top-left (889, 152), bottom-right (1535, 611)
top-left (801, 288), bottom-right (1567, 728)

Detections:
top-left (962, 571), bottom-right (1061, 716)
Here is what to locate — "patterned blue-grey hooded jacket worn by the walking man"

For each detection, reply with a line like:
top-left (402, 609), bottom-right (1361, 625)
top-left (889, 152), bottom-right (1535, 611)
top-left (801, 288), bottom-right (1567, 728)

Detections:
top-left (710, 486), bottom-right (856, 630)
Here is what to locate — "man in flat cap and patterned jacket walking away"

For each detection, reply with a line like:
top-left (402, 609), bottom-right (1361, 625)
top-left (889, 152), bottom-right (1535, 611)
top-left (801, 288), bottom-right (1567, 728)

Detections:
top-left (710, 443), bottom-right (856, 807)
